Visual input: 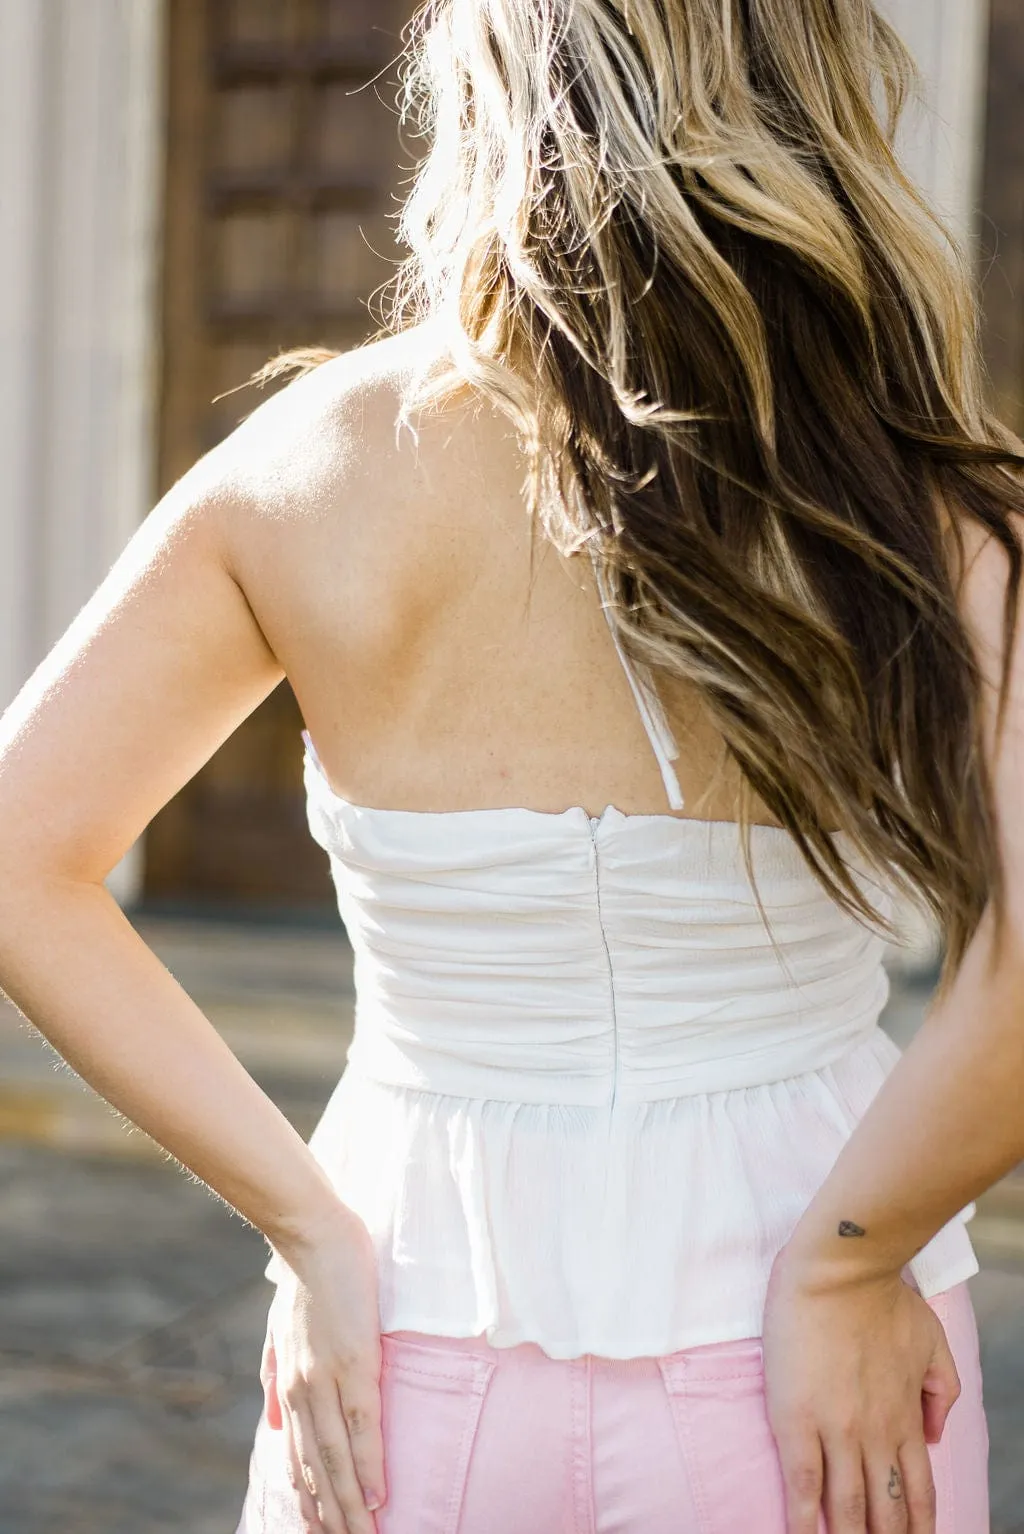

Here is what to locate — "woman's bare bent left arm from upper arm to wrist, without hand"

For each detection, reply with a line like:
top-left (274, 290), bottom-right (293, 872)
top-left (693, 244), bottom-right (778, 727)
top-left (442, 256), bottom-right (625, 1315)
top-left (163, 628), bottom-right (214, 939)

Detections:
top-left (0, 444), bottom-right (347, 1247)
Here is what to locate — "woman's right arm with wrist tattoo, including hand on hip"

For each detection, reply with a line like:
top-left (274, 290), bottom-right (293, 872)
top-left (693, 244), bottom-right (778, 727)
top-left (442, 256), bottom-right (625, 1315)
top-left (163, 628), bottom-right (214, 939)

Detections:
top-left (763, 518), bottom-right (1024, 1534)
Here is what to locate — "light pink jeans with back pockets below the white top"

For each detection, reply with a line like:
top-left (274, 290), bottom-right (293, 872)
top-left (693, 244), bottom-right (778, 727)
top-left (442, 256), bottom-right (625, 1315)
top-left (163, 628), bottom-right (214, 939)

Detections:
top-left (238, 1284), bottom-right (989, 1534)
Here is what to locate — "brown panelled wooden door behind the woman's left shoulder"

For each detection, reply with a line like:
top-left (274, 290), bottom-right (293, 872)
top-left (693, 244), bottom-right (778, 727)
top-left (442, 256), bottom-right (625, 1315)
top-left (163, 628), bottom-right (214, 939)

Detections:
top-left (144, 0), bottom-right (412, 908)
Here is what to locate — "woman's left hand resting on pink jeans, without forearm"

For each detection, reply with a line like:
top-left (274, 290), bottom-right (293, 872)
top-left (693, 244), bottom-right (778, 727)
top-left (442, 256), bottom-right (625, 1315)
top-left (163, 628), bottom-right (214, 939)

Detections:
top-left (261, 1210), bottom-right (385, 1534)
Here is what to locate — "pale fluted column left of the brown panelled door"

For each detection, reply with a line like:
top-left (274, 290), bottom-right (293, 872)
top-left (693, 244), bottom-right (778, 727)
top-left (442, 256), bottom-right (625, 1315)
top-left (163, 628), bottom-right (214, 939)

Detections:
top-left (0, 0), bottom-right (164, 900)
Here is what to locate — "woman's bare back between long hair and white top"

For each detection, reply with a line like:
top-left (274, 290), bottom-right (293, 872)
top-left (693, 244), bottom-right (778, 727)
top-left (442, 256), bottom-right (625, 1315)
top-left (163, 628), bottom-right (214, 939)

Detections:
top-left (225, 333), bottom-right (766, 819)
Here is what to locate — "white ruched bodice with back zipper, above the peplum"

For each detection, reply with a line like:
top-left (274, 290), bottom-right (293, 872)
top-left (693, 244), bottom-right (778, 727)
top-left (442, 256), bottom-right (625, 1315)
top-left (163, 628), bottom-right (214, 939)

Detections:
top-left (315, 779), bottom-right (886, 1111)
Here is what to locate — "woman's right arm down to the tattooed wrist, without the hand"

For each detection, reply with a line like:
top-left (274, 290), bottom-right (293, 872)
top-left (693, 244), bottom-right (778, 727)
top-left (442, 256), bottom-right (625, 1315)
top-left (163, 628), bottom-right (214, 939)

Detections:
top-left (775, 515), bottom-right (1024, 1282)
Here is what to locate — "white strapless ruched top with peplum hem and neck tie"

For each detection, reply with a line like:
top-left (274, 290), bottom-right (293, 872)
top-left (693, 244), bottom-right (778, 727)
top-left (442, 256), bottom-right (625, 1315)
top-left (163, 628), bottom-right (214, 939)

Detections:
top-left (267, 561), bottom-right (978, 1358)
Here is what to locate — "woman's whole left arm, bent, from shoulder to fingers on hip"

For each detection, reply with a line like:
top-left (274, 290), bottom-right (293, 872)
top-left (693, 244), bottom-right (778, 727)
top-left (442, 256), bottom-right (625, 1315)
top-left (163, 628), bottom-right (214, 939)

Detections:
top-left (0, 352), bottom-right (383, 1534)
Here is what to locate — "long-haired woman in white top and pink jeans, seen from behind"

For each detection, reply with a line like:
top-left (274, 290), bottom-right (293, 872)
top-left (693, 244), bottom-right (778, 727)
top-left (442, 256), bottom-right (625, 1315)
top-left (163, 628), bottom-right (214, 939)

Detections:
top-left (0, 0), bottom-right (1024, 1534)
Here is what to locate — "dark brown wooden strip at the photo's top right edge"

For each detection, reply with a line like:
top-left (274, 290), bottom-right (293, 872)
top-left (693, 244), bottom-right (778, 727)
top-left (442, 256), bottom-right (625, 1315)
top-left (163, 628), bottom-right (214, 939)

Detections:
top-left (980, 0), bottom-right (1024, 433)
